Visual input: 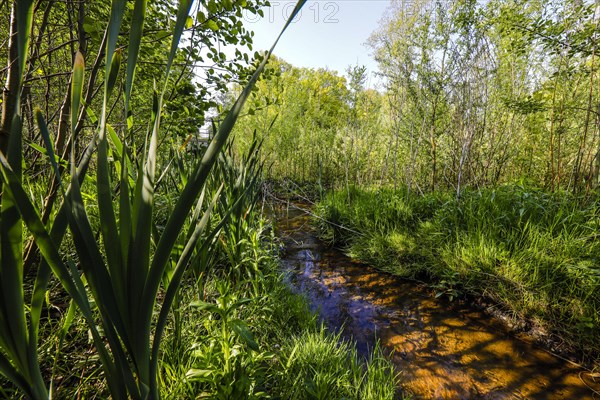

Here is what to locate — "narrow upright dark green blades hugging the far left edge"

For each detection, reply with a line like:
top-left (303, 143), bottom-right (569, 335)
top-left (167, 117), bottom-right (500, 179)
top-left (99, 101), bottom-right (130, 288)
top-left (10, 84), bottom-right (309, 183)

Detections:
top-left (0, 1), bottom-right (48, 399)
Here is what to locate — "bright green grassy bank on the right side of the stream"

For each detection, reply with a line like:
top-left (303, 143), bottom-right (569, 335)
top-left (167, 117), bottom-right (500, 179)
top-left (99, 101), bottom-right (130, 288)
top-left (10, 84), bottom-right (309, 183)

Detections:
top-left (317, 186), bottom-right (600, 357)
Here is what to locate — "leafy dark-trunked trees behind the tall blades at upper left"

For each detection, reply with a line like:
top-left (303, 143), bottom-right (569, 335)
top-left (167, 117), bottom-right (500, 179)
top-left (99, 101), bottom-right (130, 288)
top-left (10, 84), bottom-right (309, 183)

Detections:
top-left (0, 0), bottom-right (265, 169)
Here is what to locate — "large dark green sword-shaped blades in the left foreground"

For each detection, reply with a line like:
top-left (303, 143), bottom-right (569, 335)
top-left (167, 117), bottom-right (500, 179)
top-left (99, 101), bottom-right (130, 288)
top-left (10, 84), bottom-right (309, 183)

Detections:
top-left (0, 0), bottom-right (304, 399)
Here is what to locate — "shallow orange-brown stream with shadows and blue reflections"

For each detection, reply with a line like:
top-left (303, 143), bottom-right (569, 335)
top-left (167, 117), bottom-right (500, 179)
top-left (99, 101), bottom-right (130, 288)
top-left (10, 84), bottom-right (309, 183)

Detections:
top-left (277, 208), bottom-right (600, 399)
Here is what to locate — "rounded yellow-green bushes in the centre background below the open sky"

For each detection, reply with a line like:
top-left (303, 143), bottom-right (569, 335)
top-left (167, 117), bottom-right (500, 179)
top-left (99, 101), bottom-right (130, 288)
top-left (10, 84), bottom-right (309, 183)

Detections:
top-left (231, 56), bottom-right (379, 185)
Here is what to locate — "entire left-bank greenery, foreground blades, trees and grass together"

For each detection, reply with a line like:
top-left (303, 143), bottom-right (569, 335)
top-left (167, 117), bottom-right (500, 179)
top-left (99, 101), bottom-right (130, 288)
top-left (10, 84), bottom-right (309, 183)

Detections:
top-left (0, 0), bottom-right (404, 400)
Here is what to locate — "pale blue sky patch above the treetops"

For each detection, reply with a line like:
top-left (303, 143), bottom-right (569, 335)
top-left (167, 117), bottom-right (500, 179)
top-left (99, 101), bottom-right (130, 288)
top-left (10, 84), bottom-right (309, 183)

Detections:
top-left (244, 0), bottom-right (390, 86)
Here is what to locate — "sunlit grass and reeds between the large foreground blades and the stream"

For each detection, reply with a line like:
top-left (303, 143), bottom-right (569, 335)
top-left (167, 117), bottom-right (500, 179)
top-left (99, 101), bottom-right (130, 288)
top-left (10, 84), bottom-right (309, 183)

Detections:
top-left (152, 137), bottom-right (404, 400)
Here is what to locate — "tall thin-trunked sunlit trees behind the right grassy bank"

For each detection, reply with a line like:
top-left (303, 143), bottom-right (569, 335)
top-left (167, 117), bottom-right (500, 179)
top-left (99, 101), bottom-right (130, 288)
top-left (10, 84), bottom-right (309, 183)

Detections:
top-left (370, 0), bottom-right (598, 195)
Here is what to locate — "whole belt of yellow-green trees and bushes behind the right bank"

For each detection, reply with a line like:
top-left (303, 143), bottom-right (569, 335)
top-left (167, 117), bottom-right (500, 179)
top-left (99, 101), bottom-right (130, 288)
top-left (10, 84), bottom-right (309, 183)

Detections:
top-left (234, 0), bottom-right (600, 193)
